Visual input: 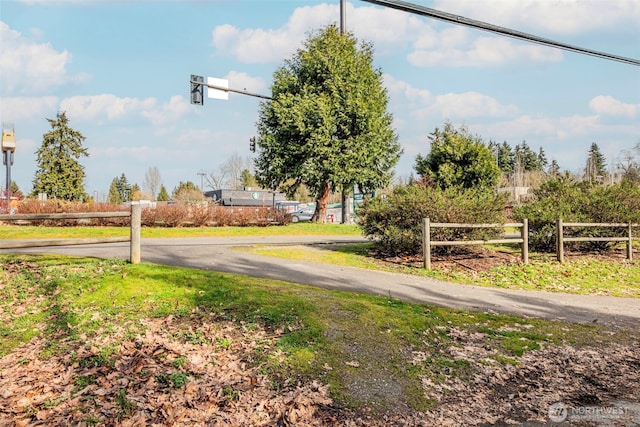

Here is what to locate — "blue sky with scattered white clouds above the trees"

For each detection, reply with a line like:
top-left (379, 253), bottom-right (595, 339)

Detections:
top-left (0, 0), bottom-right (640, 197)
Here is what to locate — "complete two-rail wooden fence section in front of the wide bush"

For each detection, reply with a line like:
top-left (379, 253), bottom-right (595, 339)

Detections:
top-left (422, 218), bottom-right (529, 270)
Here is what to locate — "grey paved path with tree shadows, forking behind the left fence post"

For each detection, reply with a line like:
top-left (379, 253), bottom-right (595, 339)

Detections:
top-left (0, 236), bottom-right (640, 329)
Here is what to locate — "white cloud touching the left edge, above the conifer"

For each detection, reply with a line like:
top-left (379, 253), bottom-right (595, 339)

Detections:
top-left (0, 22), bottom-right (87, 95)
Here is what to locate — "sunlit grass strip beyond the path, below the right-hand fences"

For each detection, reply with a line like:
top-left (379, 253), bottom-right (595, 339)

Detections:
top-left (236, 244), bottom-right (640, 298)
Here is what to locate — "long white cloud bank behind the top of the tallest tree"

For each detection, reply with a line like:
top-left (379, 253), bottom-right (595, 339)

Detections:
top-left (212, 4), bottom-right (562, 67)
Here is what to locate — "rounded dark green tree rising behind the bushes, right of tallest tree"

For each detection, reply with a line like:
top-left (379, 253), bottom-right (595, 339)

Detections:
top-left (415, 123), bottom-right (500, 189)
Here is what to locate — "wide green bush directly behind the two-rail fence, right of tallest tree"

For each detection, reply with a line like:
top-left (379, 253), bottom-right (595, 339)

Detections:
top-left (358, 184), bottom-right (506, 255)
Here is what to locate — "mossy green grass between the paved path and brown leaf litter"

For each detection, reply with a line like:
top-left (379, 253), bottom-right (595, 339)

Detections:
top-left (0, 255), bottom-right (638, 416)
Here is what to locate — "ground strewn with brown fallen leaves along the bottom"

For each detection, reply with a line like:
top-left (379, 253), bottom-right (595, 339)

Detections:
top-left (0, 312), bottom-right (640, 427)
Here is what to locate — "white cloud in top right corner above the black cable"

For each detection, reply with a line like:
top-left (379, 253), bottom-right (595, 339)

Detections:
top-left (433, 0), bottom-right (640, 35)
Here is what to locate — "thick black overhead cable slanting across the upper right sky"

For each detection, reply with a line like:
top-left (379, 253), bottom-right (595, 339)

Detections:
top-left (363, 0), bottom-right (640, 66)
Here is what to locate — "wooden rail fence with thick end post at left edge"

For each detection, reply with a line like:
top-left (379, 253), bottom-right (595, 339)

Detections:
top-left (0, 203), bottom-right (142, 264)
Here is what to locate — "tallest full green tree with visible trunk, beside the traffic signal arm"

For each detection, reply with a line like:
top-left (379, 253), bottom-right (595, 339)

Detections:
top-left (255, 25), bottom-right (402, 219)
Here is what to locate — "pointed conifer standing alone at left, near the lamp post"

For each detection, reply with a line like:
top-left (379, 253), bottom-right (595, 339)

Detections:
top-left (31, 111), bottom-right (89, 201)
